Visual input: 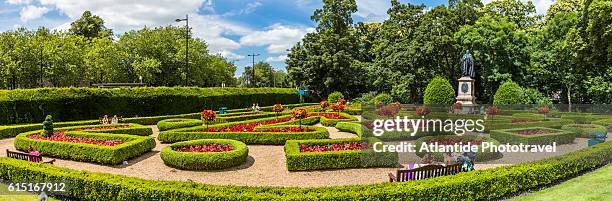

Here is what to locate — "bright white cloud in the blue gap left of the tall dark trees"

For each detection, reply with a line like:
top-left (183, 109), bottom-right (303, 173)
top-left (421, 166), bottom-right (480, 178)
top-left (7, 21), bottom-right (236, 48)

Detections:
top-left (240, 24), bottom-right (314, 53)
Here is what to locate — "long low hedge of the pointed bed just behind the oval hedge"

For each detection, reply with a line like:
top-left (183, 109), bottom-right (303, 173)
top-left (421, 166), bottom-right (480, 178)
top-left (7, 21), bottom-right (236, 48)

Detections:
top-left (158, 116), bottom-right (329, 145)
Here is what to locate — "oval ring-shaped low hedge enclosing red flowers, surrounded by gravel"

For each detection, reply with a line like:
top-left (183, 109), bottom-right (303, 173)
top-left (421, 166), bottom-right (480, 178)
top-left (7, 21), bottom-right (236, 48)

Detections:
top-left (160, 139), bottom-right (249, 170)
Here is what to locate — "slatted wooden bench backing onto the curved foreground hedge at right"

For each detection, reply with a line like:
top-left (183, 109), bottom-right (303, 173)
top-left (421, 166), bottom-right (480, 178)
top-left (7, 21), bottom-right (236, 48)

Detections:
top-left (389, 164), bottom-right (461, 182)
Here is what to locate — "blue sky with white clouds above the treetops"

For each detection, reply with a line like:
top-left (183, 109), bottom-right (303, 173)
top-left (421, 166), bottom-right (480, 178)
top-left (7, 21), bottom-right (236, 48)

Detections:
top-left (0, 0), bottom-right (554, 75)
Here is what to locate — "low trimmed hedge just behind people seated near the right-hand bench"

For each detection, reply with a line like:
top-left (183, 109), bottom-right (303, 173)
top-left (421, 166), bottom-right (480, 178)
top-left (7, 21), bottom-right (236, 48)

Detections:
top-left (415, 135), bottom-right (503, 162)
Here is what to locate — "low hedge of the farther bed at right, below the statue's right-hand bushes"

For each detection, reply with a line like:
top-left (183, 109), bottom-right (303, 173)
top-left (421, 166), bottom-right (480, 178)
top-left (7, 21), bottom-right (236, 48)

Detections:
top-left (485, 118), bottom-right (574, 132)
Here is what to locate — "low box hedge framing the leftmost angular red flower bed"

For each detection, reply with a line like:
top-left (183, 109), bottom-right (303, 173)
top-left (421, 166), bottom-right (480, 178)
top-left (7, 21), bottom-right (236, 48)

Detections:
top-left (15, 131), bottom-right (155, 165)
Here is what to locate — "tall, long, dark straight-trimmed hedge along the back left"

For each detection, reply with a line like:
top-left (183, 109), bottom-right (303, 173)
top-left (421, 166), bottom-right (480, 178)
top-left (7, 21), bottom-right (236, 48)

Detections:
top-left (0, 87), bottom-right (299, 124)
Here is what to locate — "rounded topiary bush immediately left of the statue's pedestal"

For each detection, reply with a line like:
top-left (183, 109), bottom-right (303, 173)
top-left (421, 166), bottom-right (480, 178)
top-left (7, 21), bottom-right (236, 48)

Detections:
top-left (423, 77), bottom-right (455, 105)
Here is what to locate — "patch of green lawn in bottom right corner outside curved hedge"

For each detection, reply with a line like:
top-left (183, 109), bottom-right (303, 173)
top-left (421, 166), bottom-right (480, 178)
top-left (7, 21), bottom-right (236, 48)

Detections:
top-left (511, 165), bottom-right (612, 201)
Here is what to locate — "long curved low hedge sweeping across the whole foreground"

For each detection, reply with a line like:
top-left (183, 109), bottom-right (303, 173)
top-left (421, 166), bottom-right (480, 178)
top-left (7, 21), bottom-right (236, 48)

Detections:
top-left (0, 142), bottom-right (612, 201)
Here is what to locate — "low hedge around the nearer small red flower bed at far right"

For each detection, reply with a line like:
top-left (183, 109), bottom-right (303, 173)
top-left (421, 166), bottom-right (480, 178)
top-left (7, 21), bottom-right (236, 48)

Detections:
top-left (490, 127), bottom-right (576, 145)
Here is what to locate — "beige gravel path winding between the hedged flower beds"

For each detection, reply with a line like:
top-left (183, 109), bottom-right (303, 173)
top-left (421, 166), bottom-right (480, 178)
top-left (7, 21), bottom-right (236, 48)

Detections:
top-left (0, 123), bottom-right (604, 187)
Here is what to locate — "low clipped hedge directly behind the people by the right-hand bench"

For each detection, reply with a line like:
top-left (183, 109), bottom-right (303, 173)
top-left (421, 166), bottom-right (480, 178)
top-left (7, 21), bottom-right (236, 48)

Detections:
top-left (415, 135), bottom-right (503, 162)
